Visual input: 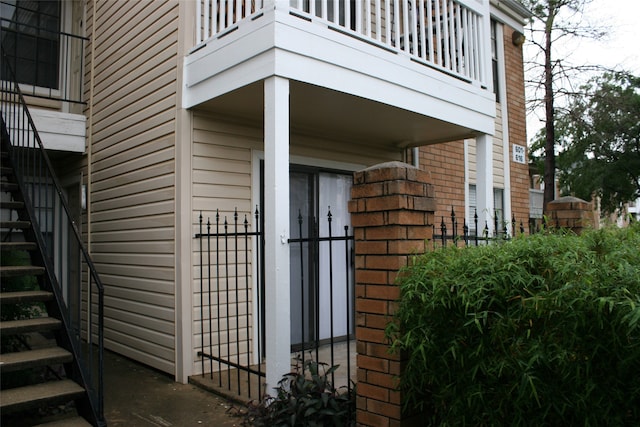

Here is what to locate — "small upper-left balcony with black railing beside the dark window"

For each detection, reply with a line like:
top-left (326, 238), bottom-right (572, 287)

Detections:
top-left (0, 16), bottom-right (88, 153)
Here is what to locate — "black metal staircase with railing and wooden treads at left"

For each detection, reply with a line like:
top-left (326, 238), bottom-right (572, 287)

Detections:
top-left (0, 47), bottom-right (106, 427)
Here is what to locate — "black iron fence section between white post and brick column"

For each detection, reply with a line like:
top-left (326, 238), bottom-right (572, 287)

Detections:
top-left (289, 209), bottom-right (355, 393)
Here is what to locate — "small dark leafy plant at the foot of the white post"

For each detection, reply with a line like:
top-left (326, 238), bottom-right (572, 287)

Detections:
top-left (239, 360), bottom-right (355, 427)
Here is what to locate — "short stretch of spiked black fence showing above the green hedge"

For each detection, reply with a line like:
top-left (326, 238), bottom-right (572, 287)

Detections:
top-left (433, 207), bottom-right (525, 247)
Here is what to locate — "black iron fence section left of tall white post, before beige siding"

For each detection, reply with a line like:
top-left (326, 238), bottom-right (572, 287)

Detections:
top-left (195, 208), bottom-right (265, 398)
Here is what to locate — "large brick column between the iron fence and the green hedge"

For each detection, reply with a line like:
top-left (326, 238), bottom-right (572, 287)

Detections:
top-left (349, 162), bottom-right (435, 427)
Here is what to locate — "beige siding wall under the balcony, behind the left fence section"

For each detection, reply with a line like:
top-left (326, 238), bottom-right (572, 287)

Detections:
top-left (192, 114), bottom-right (262, 373)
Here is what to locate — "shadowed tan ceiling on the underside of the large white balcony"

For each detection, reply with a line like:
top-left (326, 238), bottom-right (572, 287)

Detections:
top-left (196, 81), bottom-right (473, 149)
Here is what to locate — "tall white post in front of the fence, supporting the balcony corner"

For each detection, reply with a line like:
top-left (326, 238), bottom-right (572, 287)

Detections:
top-left (264, 76), bottom-right (291, 393)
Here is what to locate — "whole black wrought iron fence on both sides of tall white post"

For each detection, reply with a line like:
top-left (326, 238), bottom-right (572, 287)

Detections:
top-left (195, 208), bottom-right (355, 408)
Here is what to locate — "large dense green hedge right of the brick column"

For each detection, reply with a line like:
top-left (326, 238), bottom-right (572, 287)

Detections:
top-left (386, 223), bottom-right (640, 426)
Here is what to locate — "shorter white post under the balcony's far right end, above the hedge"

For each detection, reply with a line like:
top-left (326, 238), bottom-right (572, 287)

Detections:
top-left (476, 135), bottom-right (494, 235)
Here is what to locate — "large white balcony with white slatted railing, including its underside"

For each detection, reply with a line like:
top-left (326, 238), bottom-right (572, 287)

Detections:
top-left (183, 0), bottom-right (495, 146)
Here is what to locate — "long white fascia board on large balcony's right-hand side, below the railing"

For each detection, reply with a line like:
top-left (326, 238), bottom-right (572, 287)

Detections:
top-left (275, 19), bottom-right (495, 135)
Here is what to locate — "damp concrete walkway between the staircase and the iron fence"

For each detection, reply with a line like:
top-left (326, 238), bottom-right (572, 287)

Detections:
top-left (104, 351), bottom-right (242, 427)
